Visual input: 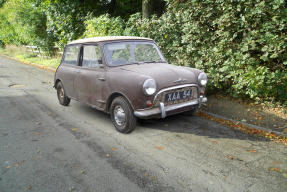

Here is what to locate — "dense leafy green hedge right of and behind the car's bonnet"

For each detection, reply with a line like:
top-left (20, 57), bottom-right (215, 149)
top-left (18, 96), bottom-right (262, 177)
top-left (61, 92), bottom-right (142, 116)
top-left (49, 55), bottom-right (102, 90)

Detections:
top-left (121, 0), bottom-right (287, 102)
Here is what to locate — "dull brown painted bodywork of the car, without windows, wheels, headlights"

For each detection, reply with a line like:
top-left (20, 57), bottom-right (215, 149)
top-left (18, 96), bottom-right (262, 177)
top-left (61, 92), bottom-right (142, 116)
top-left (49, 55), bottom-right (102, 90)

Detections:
top-left (54, 38), bottom-right (207, 117)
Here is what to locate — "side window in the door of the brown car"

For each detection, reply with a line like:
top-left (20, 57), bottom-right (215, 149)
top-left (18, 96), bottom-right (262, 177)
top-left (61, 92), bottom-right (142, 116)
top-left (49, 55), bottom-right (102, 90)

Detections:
top-left (82, 45), bottom-right (102, 68)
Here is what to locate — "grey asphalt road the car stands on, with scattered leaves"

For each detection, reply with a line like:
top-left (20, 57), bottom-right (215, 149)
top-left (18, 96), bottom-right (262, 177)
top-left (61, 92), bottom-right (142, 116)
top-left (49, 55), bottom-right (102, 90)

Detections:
top-left (0, 57), bottom-right (287, 192)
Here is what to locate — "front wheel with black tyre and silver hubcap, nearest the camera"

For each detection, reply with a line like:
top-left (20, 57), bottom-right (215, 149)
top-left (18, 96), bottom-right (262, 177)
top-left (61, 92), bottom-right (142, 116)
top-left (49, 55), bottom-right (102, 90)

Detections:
top-left (110, 97), bottom-right (137, 133)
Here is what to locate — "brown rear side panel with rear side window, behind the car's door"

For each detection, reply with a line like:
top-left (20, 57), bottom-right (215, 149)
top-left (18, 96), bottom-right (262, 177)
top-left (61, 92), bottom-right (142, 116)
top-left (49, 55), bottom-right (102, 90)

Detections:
top-left (57, 45), bottom-right (81, 99)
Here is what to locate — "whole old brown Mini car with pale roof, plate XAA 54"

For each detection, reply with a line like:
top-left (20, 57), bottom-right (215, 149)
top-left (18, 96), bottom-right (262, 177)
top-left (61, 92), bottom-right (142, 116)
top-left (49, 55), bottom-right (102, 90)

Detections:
top-left (54, 36), bottom-right (207, 133)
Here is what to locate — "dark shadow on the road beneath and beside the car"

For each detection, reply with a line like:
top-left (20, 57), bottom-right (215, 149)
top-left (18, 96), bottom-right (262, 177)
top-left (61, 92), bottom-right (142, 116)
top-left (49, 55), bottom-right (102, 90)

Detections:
top-left (77, 104), bottom-right (269, 141)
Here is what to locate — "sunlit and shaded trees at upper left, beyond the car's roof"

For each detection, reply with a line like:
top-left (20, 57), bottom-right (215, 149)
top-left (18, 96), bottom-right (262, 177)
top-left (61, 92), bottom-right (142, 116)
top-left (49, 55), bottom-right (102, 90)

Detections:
top-left (0, 0), bottom-right (151, 53)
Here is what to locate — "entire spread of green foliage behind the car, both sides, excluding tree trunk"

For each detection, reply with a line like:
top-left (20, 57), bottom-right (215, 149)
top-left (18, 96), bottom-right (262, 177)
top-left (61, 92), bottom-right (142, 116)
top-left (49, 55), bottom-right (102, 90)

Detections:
top-left (0, 0), bottom-right (287, 102)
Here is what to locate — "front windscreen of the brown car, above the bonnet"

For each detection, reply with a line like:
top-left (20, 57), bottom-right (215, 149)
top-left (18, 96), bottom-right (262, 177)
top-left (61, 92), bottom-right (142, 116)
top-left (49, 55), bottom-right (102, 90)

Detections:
top-left (104, 41), bottom-right (166, 66)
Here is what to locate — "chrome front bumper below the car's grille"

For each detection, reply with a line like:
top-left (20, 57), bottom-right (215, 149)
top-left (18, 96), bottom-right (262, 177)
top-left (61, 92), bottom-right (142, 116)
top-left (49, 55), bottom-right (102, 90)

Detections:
top-left (134, 96), bottom-right (207, 118)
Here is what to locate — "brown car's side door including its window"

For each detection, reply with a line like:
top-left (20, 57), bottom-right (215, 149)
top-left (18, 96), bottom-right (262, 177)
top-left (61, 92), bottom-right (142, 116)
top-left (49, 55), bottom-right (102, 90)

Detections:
top-left (74, 45), bottom-right (106, 108)
